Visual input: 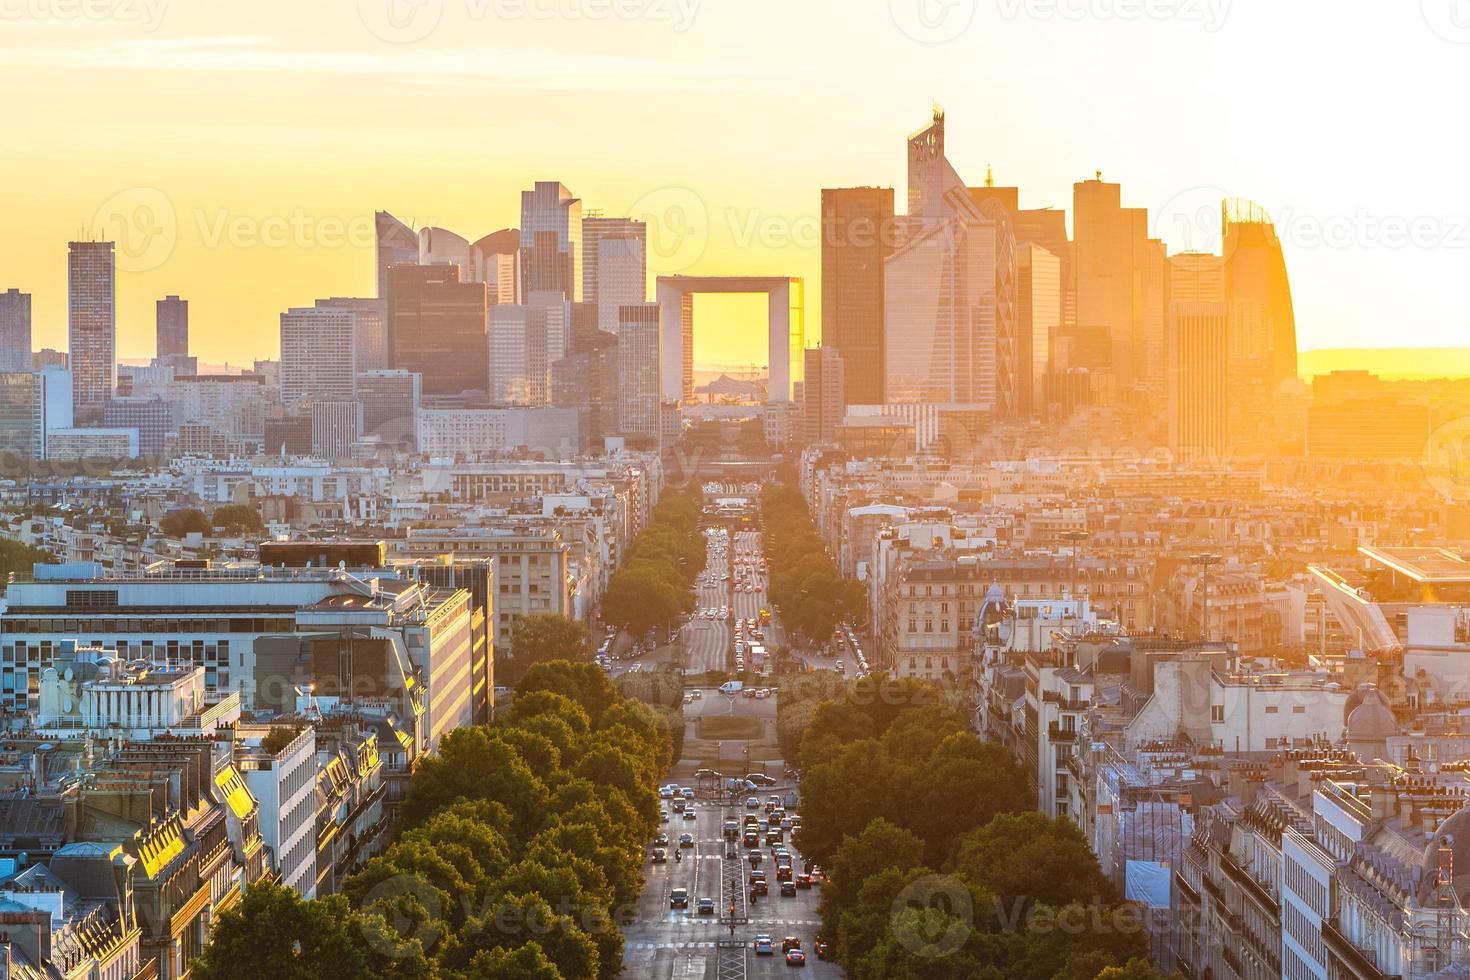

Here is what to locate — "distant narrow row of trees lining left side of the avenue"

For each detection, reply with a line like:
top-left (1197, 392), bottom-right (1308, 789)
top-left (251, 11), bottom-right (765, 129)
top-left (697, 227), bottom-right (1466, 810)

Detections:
top-left (603, 486), bottom-right (706, 636)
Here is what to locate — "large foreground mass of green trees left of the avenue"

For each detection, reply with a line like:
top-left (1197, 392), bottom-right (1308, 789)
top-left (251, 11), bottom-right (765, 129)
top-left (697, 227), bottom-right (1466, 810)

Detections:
top-left (194, 661), bottom-right (673, 980)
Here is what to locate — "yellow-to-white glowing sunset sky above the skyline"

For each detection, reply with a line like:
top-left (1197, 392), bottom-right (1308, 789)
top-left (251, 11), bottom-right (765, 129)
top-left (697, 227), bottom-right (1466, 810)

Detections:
top-left (0, 0), bottom-right (1470, 364)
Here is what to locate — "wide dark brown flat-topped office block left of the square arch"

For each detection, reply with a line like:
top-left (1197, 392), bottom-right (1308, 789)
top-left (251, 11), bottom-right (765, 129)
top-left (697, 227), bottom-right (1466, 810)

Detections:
top-left (388, 266), bottom-right (491, 397)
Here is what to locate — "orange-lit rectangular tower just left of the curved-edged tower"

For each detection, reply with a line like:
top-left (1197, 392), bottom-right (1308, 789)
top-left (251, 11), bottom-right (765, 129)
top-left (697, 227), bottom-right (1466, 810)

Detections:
top-left (1169, 301), bottom-right (1229, 460)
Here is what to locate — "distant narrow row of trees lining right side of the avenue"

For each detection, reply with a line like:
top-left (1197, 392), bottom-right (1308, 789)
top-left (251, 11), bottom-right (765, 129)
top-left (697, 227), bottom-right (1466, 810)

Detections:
top-left (760, 482), bottom-right (864, 644)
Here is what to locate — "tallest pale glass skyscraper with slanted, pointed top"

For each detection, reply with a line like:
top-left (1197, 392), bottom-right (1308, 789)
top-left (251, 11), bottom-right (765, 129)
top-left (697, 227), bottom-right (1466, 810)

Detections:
top-left (883, 113), bottom-right (1017, 417)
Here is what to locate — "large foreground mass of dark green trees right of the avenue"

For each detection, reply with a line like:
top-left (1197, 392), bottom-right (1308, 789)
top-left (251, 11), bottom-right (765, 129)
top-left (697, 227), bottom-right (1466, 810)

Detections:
top-left (797, 679), bottom-right (1158, 980)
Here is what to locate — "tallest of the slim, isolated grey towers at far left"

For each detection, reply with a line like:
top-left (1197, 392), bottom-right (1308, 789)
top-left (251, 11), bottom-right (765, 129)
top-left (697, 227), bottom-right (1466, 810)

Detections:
top-left (66, 241), bottom-right (118, 411)
